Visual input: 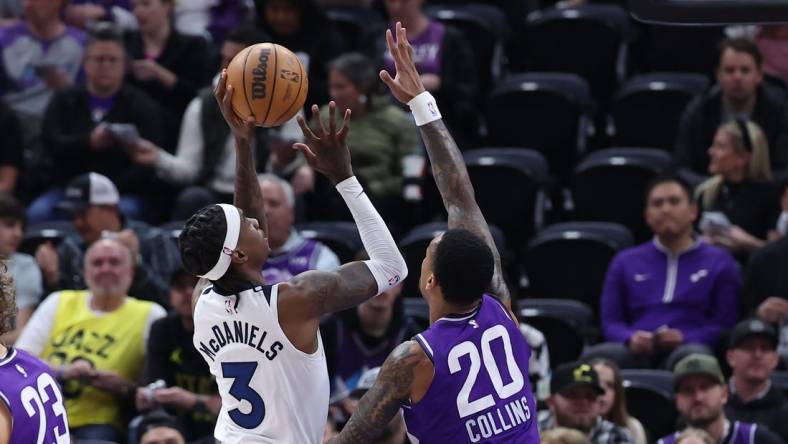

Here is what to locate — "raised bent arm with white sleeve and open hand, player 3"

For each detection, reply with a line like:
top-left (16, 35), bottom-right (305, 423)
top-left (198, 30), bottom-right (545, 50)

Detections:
top-left (284, 102), bottom-right (407, 319)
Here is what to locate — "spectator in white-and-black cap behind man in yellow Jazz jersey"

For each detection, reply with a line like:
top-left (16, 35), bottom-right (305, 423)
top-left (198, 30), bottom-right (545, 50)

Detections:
top-left (36, 172), bottom-right (180, 306)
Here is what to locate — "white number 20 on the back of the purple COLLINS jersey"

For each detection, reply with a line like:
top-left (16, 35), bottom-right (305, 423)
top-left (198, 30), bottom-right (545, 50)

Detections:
top-left (449, 324), bottom-right (525, 418)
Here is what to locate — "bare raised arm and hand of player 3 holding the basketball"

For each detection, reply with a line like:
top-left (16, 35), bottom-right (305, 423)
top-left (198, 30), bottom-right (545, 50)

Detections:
top-left (214, 70), bottom-right (268, 236)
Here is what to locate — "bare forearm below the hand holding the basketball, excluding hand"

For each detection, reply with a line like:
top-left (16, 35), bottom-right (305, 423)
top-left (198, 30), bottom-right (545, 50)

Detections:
top-left (233, 139), bottom-right (268, 235)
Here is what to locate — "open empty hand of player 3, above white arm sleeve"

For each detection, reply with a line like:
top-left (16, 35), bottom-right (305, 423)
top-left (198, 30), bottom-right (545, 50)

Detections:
top-left (293, 101), bottom-right (353, 185)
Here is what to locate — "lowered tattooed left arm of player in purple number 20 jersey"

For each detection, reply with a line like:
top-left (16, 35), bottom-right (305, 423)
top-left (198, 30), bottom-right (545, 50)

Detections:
top-left (335, 341), bottom-right (424, 444)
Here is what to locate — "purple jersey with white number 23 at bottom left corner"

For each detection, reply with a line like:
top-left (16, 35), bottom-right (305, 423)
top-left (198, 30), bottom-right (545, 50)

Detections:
top-left (0, 348), bottom-right (71, 444)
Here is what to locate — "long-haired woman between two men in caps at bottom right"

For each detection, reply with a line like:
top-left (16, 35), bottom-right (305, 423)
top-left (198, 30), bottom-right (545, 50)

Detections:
top-left (591, 358), bottom-right (646, 444)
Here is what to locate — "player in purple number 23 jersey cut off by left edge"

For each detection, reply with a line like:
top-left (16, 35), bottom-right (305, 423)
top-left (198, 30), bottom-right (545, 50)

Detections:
top-left (0, 262), bottom-right (71, 444)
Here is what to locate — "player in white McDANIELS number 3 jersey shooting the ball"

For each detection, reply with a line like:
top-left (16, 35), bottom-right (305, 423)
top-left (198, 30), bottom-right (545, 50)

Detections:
top-left (178, 72), bottom-right (407, 444)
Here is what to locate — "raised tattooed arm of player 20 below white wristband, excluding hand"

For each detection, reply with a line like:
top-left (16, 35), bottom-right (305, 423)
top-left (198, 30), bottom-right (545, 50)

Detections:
top-left (419, 120), bottom-right (510, 301)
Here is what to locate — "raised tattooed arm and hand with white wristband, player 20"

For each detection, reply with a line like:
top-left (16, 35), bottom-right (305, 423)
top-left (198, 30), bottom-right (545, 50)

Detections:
top-left (380, 22), bottom-right (510, 305)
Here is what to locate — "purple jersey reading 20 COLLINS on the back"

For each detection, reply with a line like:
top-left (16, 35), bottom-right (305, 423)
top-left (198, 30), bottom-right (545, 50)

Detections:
top-left (403, 295), bottom-right (539, 444)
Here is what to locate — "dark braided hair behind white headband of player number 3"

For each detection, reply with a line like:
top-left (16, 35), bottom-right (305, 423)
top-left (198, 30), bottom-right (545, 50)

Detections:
top-left (178, 205), bottom-right (227, 275)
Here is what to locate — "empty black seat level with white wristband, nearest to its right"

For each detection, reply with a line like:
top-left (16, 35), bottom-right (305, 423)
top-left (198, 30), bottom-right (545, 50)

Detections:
top-left (484, 73), bottom-right (593, 179)
